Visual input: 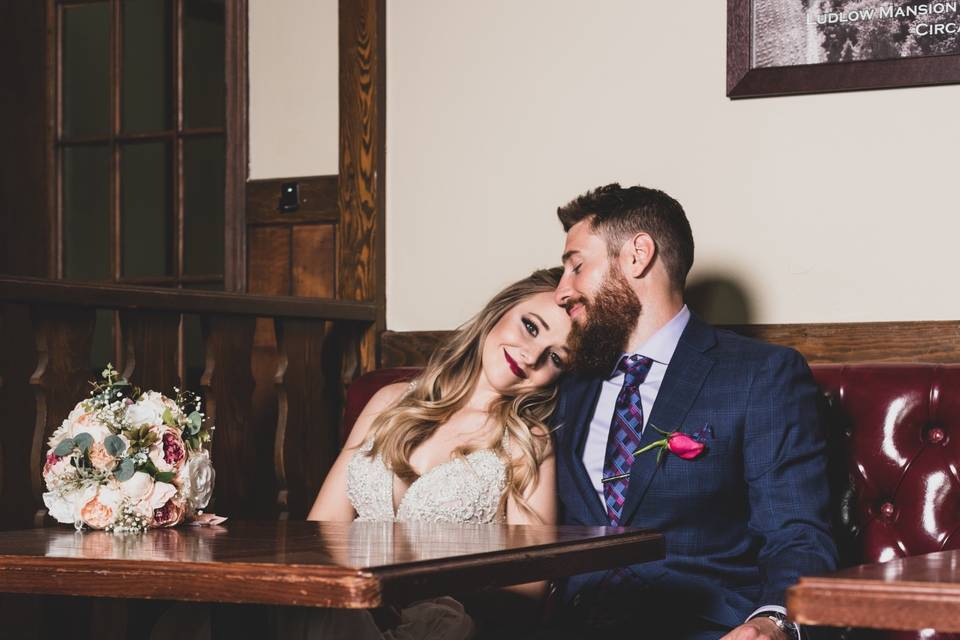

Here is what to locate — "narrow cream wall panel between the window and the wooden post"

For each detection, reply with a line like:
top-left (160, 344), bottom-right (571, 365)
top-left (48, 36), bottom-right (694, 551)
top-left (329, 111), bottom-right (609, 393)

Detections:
top-left (249, 0), bottom-right (339, 180)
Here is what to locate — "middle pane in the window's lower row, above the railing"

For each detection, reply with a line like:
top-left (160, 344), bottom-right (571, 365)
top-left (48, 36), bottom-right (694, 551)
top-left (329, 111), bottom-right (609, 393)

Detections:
top-left (120, 142), bottom-right (173, 278)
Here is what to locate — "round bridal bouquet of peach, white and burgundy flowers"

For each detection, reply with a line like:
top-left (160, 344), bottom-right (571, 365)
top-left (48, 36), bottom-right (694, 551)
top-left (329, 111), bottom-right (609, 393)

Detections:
top-left (43, 365), bottom-right (214, 533)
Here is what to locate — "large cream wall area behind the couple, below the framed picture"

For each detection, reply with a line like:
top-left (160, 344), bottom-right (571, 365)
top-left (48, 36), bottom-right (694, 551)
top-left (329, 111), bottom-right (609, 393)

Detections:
top-left (387, 0), bottom-right (960, 330)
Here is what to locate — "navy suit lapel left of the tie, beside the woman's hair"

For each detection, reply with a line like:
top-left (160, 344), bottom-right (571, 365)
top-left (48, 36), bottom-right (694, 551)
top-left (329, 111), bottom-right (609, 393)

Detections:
top-left (558, 378), bottom-right (607, 522)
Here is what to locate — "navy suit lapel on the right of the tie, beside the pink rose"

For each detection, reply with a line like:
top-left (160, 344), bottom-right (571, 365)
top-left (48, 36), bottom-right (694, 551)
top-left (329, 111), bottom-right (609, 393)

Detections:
top-left (620, 315), bottom-right (716, 526)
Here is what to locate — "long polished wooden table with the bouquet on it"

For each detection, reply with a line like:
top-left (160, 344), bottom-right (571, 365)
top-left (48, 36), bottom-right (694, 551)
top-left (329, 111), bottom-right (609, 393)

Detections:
top-left (0, 521), bottom-right (664, 608)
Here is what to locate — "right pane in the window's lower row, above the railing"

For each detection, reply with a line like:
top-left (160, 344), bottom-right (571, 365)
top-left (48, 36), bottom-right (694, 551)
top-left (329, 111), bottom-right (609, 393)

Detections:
top-left (183, 136), bottom-right (226, 275)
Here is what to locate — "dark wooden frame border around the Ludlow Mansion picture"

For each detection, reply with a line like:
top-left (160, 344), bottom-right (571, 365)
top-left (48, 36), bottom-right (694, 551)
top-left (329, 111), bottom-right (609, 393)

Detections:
top-left (727, 0), bottom-right (960, 99)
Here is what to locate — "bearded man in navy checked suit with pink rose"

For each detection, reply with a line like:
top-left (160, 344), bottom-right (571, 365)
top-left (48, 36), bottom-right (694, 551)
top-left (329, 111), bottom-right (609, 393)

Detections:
top-left (554, 184), bottom-right (836, 640)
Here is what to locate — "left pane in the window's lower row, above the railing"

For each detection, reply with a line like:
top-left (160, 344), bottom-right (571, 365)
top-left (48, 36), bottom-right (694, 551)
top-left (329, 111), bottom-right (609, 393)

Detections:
top-left (63, 145), bottom-right (111, 280)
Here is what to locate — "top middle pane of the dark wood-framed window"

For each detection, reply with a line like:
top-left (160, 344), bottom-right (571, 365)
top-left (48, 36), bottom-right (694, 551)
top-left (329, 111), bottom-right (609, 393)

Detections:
top-left (122, 0), bottom-right (173, 131)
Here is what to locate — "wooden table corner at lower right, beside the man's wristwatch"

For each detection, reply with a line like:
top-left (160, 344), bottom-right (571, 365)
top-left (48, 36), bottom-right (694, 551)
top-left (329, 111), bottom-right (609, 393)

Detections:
top-left (787, 550), bottom-right (960, 632)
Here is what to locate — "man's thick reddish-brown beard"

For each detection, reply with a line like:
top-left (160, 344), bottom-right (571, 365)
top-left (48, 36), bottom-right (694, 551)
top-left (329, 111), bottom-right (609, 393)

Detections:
top-left (569, 265), bottom-right (643, 378)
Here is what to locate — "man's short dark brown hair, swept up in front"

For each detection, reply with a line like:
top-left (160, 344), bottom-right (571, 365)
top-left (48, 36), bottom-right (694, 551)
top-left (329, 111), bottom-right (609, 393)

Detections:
top-left (557, 182), bottom-right (693, 291)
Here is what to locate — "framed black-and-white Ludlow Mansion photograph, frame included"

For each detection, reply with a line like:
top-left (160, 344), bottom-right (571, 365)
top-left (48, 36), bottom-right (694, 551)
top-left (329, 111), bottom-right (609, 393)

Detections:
top-left (727, 0), bottom-right (960, 98)
